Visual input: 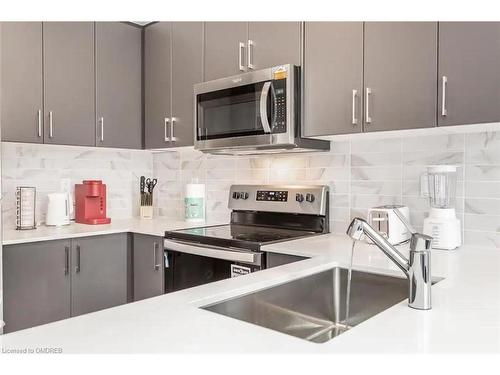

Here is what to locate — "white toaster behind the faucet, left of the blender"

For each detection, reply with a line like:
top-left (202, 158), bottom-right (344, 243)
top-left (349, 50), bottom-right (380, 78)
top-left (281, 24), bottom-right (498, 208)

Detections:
top-left (368, 205), bottom-right (411, 245)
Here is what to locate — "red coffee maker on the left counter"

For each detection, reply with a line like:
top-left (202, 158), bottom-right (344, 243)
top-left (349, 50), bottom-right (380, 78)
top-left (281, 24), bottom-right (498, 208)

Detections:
top-left (75, 180), bottom-right (111, 224)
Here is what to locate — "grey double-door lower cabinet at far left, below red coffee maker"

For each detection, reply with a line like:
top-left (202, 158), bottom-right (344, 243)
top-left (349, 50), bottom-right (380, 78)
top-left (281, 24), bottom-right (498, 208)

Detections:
top-left (3, 233), bottom-right (131, 333)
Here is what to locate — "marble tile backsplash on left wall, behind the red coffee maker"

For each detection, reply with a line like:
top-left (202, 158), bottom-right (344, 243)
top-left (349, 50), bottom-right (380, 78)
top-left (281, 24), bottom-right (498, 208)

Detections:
top-left (2, 142), bottom-right (153, 227)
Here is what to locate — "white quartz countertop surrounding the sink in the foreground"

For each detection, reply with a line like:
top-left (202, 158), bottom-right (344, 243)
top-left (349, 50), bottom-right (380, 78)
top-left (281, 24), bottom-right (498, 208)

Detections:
top-left (0, 234), bottom-right (500, 353)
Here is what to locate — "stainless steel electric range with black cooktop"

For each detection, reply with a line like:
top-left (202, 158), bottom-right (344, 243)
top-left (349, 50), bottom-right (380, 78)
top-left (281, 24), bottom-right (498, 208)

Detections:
top-left (164, 185), bottom-right (329, 293)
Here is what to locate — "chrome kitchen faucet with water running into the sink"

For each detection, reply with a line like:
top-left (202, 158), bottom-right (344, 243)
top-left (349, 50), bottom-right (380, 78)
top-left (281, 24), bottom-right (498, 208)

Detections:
top-left (347, 212), bottom-right (432, 310)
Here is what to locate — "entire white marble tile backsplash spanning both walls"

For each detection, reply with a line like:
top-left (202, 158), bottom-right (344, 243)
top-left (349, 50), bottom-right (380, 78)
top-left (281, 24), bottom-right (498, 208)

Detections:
top-left (2, 124), bottom-right (500, 248)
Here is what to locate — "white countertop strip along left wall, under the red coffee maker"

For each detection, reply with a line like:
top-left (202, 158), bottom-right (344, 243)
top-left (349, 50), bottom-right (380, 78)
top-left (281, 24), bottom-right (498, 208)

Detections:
top-left (2, 218), bottom-right (225, 246)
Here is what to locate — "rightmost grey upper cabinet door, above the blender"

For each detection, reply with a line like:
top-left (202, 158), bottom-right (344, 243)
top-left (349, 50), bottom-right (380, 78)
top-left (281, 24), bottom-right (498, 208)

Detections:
top-left (438, 22), bottom-right (500, 125)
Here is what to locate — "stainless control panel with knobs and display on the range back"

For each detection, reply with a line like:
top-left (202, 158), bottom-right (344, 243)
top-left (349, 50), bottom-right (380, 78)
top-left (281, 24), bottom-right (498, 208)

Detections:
top-left (228, 185), bottom-right (329, 215)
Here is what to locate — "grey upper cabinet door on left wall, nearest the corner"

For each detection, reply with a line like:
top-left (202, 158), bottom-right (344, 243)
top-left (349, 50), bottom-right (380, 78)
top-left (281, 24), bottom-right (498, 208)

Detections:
top-left (96, 22), bottom-right (142, 149)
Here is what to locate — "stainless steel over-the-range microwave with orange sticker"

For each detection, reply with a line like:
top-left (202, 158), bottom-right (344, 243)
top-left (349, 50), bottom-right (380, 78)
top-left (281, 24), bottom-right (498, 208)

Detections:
top-left (194, 64), bottom-right (330, 154)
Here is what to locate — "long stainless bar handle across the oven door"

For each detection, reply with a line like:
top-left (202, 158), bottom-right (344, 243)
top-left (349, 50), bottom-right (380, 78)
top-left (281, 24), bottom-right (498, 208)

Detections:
top-left (163, 239), bottom-right (262, 264)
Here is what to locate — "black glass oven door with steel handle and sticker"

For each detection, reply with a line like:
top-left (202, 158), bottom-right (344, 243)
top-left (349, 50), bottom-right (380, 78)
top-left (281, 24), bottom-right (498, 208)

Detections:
top-left (164, 239), bottom-right (264, 293)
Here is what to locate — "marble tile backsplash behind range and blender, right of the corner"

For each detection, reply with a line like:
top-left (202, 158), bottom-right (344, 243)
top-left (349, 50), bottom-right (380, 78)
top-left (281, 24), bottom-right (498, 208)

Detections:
top-left (153, 129), bottom-right (500, 248)
